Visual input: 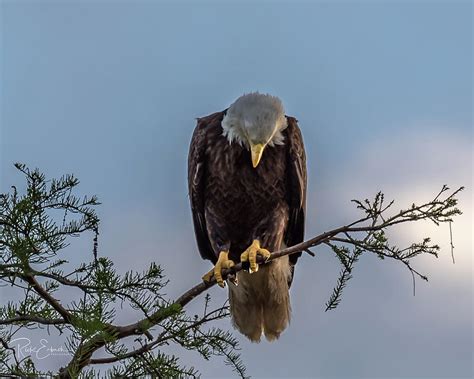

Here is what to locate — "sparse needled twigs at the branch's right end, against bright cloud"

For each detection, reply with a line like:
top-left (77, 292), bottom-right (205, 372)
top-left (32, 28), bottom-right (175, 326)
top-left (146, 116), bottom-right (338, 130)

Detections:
top-left (324, 186), bottom-right (463, 311)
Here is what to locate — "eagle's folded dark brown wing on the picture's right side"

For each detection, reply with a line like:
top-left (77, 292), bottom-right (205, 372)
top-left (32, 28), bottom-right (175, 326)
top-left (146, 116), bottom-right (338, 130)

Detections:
top-left (285, 117), bottom-right (306, 264)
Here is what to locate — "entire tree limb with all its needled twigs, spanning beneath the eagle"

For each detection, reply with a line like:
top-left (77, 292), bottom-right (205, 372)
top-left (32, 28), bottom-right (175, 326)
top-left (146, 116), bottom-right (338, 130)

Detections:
top-left (0, 165), bottom-right (462, 378)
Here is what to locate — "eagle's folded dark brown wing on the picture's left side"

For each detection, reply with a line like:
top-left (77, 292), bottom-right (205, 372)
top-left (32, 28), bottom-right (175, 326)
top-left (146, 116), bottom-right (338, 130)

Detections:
top-left (188, 112), bottom-right (224, 264)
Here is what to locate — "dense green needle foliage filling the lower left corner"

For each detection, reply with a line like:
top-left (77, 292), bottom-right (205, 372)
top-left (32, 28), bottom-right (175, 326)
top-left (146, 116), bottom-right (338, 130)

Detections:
top-left (0, 164), bottom-right (245, 377)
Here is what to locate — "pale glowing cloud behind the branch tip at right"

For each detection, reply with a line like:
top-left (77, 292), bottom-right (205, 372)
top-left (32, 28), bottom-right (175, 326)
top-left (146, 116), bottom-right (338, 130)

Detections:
top-left (309, 124), bottom-right (473, 280)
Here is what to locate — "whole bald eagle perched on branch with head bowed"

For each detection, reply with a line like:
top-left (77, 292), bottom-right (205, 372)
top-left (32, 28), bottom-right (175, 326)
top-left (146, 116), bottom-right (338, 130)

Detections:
top-left (188, 93), bottom-right (306, 342)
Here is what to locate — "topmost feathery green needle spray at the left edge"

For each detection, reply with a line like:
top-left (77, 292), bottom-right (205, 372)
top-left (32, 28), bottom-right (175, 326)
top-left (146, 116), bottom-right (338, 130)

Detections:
top-left (0, 163), bottom-right (99, 269)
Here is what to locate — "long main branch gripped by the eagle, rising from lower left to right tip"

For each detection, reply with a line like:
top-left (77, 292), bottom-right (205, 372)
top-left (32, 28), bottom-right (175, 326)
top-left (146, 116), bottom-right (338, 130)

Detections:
top-left (57, 187), bottom-right (463, 378)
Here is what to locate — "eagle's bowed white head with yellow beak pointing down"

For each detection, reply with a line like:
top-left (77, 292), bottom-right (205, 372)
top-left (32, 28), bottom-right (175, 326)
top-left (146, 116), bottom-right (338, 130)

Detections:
top-left (222, 92), bottom-right (288, 167)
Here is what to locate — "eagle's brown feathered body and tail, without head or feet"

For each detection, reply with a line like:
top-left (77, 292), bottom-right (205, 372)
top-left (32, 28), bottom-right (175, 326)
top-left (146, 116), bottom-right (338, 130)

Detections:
top-left (188, 111), bottom-right (306, 341)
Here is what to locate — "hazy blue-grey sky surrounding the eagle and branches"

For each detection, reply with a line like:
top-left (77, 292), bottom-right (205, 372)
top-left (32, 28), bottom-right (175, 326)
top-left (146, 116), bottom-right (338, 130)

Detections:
top-left (0, 0), bottom-right (474, 378)
